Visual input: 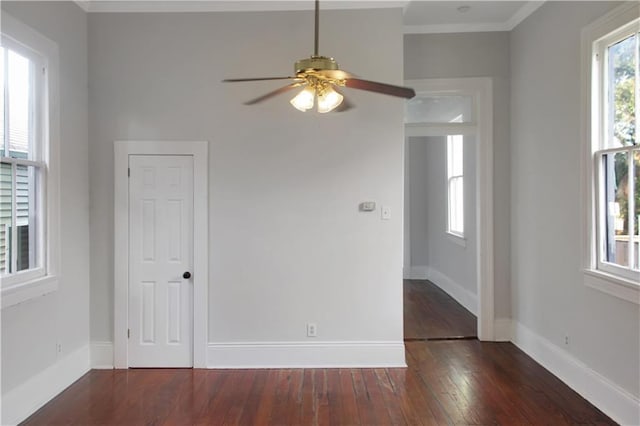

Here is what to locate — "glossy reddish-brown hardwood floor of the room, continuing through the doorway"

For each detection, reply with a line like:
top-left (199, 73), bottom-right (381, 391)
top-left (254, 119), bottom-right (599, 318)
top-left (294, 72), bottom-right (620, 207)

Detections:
top-left (23, 282), bottom-right (615, 426)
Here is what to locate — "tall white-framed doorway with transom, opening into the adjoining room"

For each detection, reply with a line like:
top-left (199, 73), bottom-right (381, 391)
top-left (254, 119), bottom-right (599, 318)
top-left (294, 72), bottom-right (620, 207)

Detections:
top-left (403, 78), bottom-right (495, 341)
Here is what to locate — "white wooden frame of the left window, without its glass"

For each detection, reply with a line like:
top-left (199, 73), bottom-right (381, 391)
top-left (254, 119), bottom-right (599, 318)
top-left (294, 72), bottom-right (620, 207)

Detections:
top-left (0, 11), bottom-right (60, 309)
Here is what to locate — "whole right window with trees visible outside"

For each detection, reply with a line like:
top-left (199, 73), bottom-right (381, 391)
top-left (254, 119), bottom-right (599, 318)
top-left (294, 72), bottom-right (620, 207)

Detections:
top-left (587, 7), bottom-right (640, 294)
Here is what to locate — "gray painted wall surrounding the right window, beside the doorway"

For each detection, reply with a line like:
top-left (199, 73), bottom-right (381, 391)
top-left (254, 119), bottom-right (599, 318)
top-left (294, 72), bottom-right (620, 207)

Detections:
top-left (511, 2), bottom-right (640, 397)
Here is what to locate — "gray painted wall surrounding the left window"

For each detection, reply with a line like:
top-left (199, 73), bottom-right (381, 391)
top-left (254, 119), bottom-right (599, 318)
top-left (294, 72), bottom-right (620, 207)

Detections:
top-left (1, 1), bottom-right (89, 394)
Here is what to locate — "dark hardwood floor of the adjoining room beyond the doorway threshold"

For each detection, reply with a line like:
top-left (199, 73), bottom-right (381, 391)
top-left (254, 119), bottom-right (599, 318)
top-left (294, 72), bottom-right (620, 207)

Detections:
top-left (404, 280), bottom-right (478, 340)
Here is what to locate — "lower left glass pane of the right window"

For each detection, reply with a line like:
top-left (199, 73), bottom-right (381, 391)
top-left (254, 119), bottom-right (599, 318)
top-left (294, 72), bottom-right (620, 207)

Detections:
top-left (603, 152), bottom-right (629, 267)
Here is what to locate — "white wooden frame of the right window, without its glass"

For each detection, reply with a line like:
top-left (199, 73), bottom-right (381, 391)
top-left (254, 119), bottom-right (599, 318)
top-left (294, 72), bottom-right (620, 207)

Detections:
top-left (581, 2), bottom-right (640, 304)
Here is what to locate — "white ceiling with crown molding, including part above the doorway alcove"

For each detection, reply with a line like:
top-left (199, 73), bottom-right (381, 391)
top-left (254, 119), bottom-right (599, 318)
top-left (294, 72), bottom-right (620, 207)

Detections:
top-left (76, 0), bottom-right (544, 33)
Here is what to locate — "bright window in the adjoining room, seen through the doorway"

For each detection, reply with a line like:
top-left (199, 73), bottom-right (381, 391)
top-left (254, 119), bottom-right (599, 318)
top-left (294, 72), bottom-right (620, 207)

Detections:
top-left (447, 135), bottom-right (464, 238)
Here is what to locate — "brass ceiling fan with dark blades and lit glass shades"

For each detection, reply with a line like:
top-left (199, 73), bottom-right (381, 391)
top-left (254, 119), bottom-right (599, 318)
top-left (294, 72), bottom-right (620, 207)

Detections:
top-left (222, 0), bottom-right (415, 113)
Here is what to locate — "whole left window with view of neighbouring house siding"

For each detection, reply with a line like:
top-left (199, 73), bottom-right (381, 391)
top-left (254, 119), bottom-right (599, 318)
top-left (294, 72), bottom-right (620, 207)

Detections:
top-left (0, 13), bottom-right (59, 307)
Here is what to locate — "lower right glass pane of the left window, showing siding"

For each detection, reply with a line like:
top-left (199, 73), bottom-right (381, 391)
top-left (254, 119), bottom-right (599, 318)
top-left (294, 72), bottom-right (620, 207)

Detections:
top-left (15, 166), bottom-right (39, 271)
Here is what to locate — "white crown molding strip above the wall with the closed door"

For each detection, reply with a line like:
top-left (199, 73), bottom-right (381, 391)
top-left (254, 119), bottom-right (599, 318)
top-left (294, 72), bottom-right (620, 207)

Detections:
top-left (82, 0), bottom-right (409, 13)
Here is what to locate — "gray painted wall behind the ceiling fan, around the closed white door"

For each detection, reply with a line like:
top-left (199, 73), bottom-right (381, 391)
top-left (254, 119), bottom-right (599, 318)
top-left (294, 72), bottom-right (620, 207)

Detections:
top-left (89, 9), bottom-right (404, 342)
